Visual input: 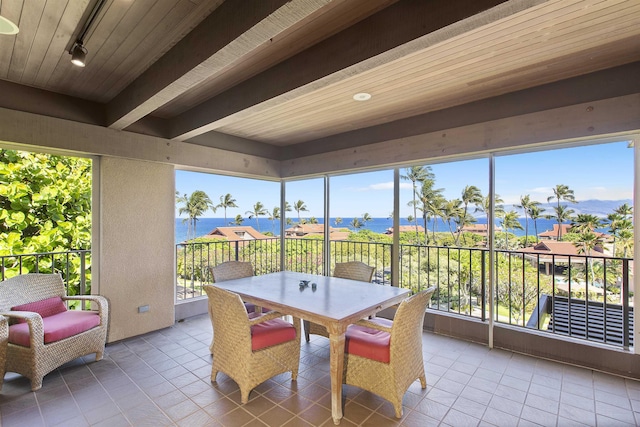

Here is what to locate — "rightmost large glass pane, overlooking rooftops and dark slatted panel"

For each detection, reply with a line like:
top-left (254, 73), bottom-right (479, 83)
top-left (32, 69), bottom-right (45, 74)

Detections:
top-left (495, 141), bottom-right (633, 344)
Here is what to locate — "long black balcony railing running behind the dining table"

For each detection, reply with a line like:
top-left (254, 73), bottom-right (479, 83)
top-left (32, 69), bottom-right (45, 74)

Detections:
top-left (176, 238), bottom-right (633, 348)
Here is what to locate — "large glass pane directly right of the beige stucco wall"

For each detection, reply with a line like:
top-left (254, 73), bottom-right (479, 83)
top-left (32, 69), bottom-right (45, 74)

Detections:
top-left (175, 171), bottom-right (280, 299)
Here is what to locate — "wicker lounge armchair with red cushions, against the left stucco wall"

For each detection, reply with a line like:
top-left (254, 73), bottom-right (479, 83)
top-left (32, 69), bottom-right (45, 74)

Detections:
top-left (0, 273), bottom-right (109, 391)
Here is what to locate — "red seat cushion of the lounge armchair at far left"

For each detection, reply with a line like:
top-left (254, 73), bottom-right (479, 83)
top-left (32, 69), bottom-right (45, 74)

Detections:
top-left (9, 310), bottom-right (100, 347)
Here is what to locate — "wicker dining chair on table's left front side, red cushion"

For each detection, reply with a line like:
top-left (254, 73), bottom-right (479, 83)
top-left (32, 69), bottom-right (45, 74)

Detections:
top-left (204, 285), bottom-right (300, 403)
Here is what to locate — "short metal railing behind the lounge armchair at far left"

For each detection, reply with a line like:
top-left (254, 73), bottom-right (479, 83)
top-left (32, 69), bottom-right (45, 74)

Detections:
top-left (0, 249), bottom-right (91, 295)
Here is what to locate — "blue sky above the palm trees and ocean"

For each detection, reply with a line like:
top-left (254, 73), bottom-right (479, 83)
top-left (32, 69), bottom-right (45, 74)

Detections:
top-left (176, 141), bottom-right (633, 218)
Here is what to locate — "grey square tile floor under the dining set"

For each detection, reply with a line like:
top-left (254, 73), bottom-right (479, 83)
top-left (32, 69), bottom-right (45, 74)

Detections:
top-left (0, 316), bottom-right (640, 427)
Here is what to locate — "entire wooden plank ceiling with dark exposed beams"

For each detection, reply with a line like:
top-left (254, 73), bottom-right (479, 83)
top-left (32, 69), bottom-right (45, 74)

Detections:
top-left (0, 0), bottom-right (640, 159)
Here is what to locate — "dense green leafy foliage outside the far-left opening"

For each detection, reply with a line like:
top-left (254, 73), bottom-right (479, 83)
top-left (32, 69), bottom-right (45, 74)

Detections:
top-left (0, 150), bottom-right (91, 294)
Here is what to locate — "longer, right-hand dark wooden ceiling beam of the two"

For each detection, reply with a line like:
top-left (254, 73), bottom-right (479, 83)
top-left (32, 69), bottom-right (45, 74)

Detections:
top-left (169, 0), bottom-right (516, 140)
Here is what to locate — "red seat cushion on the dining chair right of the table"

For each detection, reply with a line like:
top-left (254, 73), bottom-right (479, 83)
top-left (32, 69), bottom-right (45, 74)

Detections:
top-left (345, 318), bottom-right (393, 363)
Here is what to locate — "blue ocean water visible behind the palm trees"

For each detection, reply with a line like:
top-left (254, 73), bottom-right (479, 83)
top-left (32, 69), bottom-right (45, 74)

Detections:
top-left (176, 218), bottom-right (584, 244)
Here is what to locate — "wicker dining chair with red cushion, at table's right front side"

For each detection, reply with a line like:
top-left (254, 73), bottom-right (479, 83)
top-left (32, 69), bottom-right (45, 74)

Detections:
top-left (343, 287), bottom-right (435, 418)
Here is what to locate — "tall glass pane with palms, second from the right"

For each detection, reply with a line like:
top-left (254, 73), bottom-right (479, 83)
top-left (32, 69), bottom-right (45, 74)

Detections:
top-left (400, 159), bottom-right (489, 319)
